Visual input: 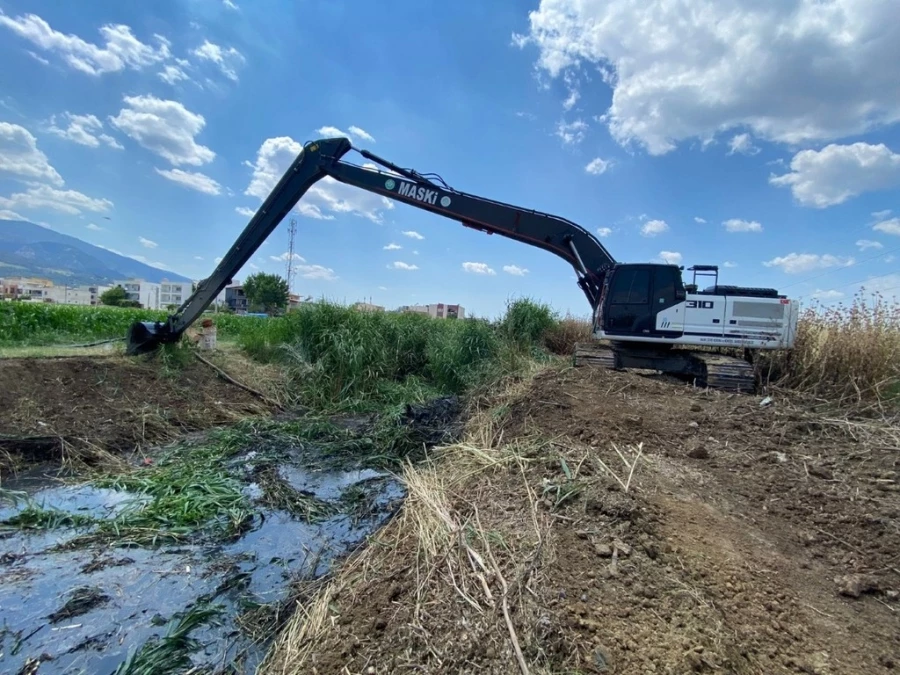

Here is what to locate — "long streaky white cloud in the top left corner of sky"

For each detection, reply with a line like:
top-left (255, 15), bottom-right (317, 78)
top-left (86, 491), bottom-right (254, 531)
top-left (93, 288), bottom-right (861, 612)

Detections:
top-left (0, 11), bottom-right (171, 75)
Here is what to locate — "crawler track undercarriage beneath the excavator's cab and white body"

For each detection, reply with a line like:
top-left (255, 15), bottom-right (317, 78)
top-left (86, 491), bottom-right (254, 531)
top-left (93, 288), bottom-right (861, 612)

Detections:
top-left (573, 342), bottom-right (756, 393)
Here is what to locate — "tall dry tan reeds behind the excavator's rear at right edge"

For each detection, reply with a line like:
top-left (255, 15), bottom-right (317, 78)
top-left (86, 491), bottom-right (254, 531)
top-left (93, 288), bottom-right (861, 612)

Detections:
top-left (761, 292), bottom-right (900, 402)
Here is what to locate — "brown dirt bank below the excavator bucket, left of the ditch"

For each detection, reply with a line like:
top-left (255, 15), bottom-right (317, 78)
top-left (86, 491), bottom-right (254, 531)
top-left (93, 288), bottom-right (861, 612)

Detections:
top-left (0, 357), bottom-right (272, 472)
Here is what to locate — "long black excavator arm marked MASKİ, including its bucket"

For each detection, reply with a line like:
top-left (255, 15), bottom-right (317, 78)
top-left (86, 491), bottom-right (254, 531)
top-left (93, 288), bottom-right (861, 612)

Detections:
top-left (127, 138), bottom-right (616, 354)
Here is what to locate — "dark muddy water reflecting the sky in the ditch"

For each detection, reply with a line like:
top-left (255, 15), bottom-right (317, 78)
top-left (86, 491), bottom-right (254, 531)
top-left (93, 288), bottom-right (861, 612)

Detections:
top-left (0, 453), bottom-right (404, 675)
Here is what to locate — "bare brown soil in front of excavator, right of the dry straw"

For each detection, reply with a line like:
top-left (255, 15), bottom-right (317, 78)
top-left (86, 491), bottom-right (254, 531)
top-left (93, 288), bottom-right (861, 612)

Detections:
top-left (509, 369), bottom-right (900, 674)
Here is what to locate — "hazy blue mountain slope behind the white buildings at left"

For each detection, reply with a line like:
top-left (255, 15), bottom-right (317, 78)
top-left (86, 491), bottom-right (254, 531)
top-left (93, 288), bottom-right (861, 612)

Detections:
top-left (0, 220), bottom-right (190, 286)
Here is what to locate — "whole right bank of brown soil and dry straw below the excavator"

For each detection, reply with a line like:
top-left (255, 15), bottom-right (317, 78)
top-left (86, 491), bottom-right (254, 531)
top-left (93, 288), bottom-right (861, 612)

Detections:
top-left (278, 368), bottom-right (900, 675)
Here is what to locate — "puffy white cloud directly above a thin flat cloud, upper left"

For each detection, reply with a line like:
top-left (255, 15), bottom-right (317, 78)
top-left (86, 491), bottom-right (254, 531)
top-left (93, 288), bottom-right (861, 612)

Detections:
top-left (110, 95), bottom-right (216, 166)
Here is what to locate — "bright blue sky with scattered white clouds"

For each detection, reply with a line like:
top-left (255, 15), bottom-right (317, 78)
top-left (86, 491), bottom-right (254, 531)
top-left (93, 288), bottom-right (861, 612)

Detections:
top-left (0, 0), bottom-right (900, 315)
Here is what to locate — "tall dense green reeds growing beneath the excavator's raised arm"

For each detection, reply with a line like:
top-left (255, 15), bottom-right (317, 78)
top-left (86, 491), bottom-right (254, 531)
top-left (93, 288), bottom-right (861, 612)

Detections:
top-left (237, 300), bottom-right (557, 410)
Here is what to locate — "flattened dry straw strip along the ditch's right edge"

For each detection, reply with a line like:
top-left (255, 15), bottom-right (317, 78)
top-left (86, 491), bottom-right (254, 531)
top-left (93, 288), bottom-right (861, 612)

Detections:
top-left (261, 362), bottom-right (555, 675)
